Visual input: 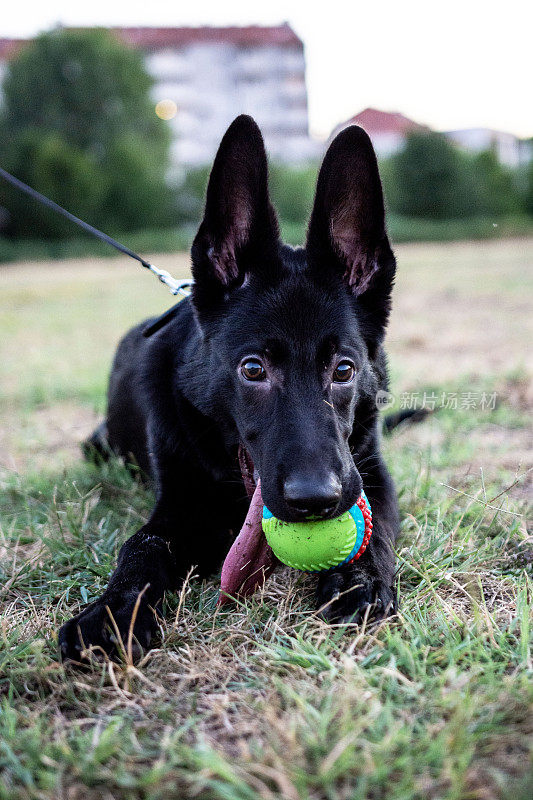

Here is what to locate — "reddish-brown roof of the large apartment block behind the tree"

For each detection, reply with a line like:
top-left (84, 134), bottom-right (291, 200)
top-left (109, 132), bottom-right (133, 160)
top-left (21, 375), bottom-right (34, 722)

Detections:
top-left (0, 22), bottom-right (303, 60)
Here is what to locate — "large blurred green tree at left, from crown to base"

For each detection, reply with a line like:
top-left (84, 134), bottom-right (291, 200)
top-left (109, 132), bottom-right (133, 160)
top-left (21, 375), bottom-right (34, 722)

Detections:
top-left (0, 29), bottom-right (172, 236)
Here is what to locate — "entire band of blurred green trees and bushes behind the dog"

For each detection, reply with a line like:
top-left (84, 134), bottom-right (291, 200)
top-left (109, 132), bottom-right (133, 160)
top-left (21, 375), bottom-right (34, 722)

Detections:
top-left (0, 35), bottom-right (533, 261)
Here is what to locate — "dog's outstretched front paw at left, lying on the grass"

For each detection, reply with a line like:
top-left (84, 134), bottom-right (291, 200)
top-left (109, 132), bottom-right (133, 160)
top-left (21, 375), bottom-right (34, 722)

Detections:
top-left (59, 593), bottom-right (157, 664)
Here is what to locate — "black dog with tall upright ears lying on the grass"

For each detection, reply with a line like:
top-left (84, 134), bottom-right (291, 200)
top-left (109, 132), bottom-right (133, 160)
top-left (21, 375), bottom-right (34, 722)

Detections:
top-left (59, 116), bottom-right (399, 660)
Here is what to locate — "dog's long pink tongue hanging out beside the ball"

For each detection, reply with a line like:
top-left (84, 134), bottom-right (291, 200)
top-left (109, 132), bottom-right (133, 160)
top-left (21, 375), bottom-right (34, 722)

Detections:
top-left (218, 481), bottom-right (275, 605)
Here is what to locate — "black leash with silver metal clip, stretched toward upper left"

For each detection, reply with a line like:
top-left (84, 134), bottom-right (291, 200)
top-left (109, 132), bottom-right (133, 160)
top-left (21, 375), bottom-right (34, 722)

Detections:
top-left (0, 167), bottom-right (193, 336)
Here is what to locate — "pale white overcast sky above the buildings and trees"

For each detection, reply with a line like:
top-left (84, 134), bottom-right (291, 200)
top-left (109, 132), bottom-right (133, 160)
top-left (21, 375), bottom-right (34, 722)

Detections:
top-left (0, 0), bottom-right (533, 136)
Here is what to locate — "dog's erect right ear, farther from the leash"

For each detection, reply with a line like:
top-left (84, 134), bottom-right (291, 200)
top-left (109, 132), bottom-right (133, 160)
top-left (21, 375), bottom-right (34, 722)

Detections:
top-left (307, 125), bottom-right (395, 346)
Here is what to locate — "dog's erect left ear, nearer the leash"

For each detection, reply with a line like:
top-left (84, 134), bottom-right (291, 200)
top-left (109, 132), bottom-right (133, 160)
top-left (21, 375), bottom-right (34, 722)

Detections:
top-left (192, 114), bottom-right (279, 316)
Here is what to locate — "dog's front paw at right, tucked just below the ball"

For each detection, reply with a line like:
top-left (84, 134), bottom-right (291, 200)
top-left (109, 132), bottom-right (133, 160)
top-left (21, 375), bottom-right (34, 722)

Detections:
top-left (316, 565), bottom-right (396, 624)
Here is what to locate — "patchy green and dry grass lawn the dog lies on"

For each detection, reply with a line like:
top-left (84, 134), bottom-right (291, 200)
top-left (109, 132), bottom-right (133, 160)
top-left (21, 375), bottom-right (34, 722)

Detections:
top-left (0, 239), bottom-right (533, 800)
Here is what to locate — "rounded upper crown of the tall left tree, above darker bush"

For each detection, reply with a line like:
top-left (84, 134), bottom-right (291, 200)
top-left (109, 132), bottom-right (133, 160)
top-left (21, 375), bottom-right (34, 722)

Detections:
top-left (3, 29), bottom-right (159, 152)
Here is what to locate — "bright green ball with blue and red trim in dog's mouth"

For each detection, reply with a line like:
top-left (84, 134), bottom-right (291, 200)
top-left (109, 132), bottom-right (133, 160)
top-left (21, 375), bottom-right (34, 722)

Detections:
top-left (262, 493), bottom-right (372, 572)
